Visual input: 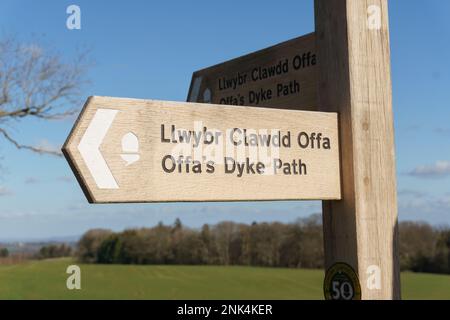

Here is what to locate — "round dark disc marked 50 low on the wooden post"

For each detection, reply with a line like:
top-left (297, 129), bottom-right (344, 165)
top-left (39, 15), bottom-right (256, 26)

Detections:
top-left (323, 262), bottom-right (361, 300)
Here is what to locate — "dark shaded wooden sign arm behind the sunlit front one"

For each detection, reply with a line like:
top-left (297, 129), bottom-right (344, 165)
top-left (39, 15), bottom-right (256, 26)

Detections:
top-left (188, 33), bottom-right (318, 110)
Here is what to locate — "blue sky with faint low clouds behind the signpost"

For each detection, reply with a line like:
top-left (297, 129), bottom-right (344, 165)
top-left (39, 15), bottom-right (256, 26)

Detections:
top-left (0, 0), bottom-right (450, 239)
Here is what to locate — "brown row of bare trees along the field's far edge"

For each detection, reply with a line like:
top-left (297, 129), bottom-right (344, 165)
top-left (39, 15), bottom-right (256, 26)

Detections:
top-left (75, 215), bottom-right (450, 273)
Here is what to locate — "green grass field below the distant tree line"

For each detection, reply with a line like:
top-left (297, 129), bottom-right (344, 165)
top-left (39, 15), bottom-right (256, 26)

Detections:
top-left (0, 259), bottom-right (450, 299)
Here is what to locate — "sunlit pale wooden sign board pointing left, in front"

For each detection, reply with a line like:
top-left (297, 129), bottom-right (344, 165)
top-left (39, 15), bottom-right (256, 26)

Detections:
top-left (63, 97), bottom-right (340, 203)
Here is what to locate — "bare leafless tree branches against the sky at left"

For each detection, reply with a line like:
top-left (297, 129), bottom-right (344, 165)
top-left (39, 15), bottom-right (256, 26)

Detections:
top-left (0, 39), bottom-right (89, 156)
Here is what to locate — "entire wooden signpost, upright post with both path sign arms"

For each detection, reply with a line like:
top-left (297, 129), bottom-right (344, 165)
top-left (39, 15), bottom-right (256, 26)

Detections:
top-left (63, 0), bottom-right (400, 300)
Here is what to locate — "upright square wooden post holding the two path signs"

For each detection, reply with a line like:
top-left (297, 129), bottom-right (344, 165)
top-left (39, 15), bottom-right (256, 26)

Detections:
top-left (315, 0), bottom-right (400, 299)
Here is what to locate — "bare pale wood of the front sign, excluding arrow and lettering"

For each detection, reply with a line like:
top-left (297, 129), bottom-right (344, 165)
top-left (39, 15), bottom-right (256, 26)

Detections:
top-left (63, 97), bottom-right (340, 203)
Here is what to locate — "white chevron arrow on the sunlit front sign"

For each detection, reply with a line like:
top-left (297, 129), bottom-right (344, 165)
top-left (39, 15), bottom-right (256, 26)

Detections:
top-left (78, 109), bottom-right (119, 189)
